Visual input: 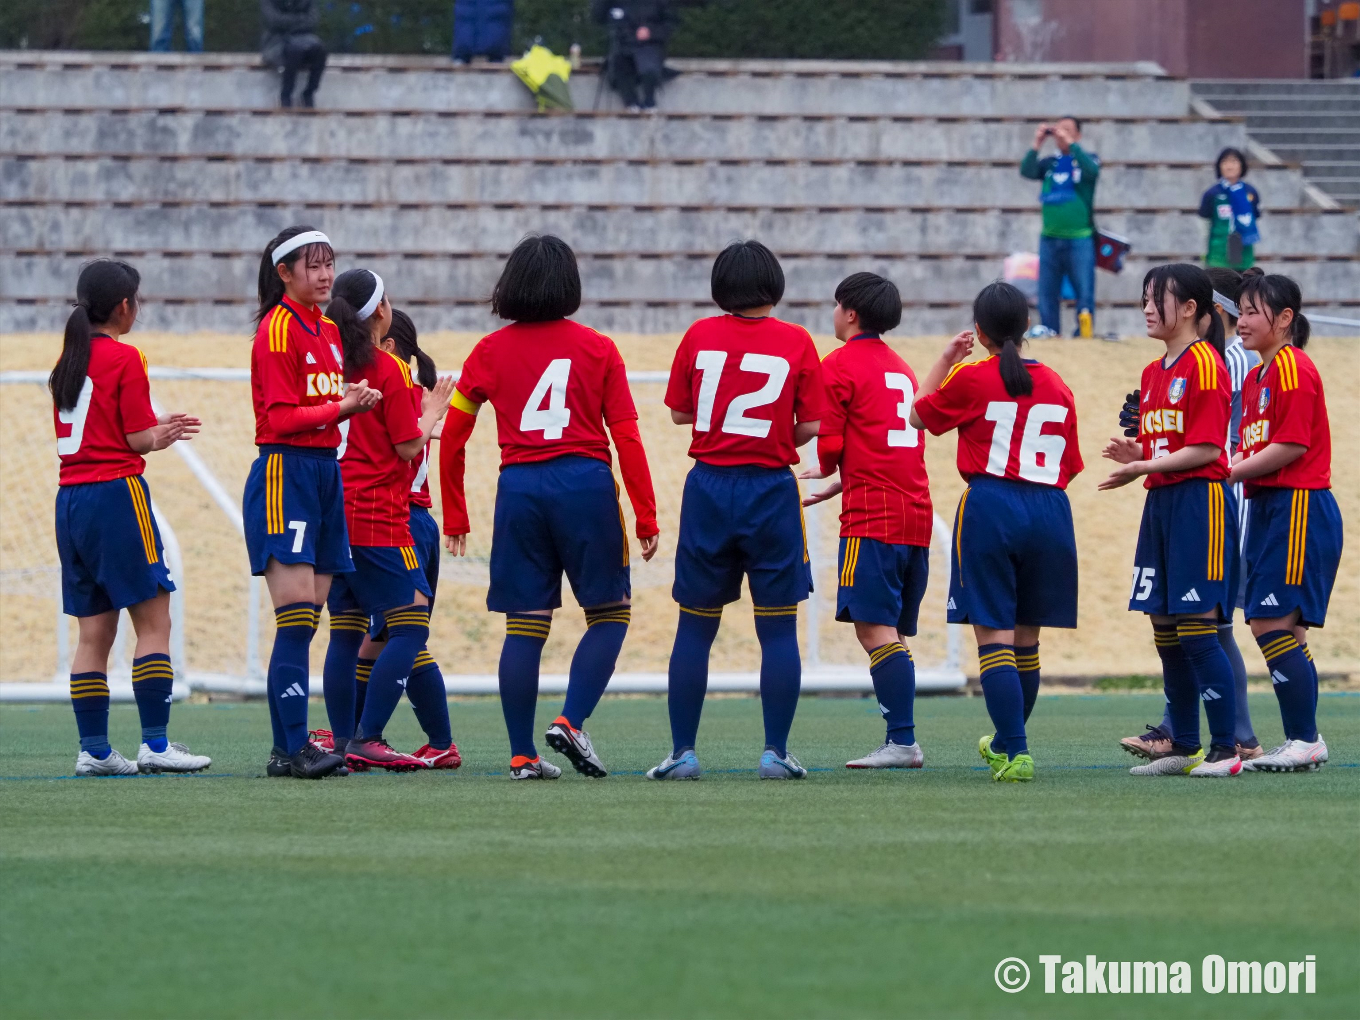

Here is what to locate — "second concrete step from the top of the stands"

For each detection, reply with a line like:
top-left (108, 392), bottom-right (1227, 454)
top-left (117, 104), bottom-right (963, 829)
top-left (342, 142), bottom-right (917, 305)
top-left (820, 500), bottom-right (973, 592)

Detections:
top-left (0, 105), bottom-right (1246, 162)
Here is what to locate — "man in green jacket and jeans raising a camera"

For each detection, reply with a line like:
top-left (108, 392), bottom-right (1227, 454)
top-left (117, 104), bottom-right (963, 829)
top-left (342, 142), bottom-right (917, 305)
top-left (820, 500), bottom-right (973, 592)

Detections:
top-left (1020, 117), bottom-right (1100, 336)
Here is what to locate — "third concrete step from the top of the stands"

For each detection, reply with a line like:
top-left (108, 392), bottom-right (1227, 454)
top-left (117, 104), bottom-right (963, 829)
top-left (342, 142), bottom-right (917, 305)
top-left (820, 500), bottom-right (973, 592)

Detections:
top-left (0, 152), bottom-right (1308, 209)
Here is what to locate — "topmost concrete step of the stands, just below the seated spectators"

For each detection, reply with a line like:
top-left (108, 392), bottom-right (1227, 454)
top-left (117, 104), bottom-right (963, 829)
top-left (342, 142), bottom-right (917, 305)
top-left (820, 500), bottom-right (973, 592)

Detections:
top-left (0, 52), bottom-right (1190, 117)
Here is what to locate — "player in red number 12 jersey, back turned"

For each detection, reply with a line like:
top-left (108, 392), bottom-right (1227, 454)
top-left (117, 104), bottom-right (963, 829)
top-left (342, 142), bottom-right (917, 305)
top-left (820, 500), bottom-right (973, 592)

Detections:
top-left (647, 241), bottom-right (826, 779)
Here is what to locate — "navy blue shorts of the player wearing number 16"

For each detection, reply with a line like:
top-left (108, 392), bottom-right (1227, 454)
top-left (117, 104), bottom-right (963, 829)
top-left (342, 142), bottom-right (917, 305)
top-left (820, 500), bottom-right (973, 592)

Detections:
top-left (945, 475), bottom-right (1077, 631)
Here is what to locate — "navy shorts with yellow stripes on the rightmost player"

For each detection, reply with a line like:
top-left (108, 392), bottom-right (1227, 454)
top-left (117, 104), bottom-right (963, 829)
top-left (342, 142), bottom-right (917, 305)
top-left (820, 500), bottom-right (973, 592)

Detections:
top-left (1243, 488), bottom-right (1342, 627)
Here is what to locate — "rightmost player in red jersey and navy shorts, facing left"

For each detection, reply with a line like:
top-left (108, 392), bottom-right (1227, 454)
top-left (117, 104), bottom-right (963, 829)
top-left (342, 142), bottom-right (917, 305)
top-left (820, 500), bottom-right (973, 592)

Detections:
top-left (1229, 276), bottom-right (1342, 772)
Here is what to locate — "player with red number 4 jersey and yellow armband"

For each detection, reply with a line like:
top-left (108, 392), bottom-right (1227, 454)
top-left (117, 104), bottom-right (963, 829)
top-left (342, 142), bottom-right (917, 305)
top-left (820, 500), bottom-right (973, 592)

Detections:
top-left (439, 234), bottom-right (658, 779)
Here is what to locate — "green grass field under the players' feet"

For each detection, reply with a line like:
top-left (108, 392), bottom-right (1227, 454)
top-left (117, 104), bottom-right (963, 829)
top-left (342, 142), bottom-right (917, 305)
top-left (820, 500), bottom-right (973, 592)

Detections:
top-left (0, 694), bottom-right (1360, 1017)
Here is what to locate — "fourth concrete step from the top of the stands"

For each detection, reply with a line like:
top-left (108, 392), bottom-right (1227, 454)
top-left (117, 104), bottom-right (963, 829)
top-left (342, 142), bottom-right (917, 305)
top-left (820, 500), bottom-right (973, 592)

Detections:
top-left (0, 203), bottom-right (1357, 258)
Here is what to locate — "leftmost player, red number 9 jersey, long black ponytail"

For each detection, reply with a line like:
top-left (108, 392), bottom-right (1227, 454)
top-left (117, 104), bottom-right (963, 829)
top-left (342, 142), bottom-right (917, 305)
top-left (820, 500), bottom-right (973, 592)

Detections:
top-left (48, 258), bottom-right (212, 775)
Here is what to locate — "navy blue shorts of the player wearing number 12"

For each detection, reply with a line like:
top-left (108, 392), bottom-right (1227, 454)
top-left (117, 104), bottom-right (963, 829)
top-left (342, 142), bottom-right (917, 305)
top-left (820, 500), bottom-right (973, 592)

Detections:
top-left (670, 461), bottom-right (812, 609)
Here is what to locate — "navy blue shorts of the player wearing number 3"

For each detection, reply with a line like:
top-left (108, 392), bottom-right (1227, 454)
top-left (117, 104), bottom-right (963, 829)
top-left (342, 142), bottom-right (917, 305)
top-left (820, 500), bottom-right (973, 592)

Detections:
top-left (836, 536), bottom-right (930, 638)
